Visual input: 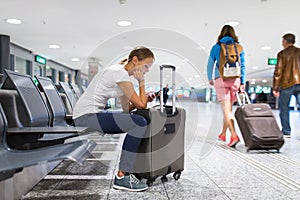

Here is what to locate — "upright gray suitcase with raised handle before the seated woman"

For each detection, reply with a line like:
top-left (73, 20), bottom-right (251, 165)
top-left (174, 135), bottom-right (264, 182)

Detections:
top-left (135, 65), bottom-right (186, 186)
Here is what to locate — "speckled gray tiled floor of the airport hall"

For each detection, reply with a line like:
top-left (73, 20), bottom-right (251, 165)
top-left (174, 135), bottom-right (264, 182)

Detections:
top-left (23, 102), bottom-right (300, 200)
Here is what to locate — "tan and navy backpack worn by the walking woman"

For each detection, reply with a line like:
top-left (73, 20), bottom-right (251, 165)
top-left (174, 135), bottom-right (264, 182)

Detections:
top-left (217, 42), bottom-right (243, 79)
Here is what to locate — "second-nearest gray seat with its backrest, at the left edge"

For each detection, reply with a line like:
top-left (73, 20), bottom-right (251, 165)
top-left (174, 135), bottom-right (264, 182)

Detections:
top-left (0, 89), bottom-right (88, 148)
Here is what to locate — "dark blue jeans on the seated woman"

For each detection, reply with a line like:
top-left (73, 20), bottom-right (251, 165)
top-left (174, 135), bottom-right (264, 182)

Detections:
top-left (74, 111), bottom-right (147, 173)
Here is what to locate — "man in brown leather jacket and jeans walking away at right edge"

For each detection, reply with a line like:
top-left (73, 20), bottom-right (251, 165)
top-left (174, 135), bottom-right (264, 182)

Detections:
top-left (273, 33), bottom-right (300, 137)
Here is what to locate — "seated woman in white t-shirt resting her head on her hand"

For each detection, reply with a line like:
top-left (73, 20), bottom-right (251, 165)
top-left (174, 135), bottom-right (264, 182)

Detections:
top-left (73, 47), bottom-right (155, 191)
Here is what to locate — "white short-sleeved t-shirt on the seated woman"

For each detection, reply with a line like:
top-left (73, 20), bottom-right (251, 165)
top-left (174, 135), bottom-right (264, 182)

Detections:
top-left (73, 65), bottom-right (134, 119)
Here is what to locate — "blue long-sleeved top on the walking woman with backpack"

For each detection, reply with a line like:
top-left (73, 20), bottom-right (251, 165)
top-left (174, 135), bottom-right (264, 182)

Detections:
top-left (207, 36), bottom-right (246, 85)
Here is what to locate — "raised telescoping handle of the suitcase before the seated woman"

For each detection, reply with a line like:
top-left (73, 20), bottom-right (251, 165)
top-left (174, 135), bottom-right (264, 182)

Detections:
top-left (160, 65), bottom-right (176, 114)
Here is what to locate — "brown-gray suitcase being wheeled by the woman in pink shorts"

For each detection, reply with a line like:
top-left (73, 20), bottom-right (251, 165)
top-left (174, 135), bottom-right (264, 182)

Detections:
top-left (234, 93), bottom-right (284, 152)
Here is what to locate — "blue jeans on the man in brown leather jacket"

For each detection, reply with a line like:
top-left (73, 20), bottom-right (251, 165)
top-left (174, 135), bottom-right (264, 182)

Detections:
top-left (279, 84), bottom-right (300, 135)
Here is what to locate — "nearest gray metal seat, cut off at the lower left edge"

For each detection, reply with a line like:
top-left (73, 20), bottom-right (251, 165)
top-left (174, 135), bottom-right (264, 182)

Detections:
top-left (0, 104), bottom-right (96, 180)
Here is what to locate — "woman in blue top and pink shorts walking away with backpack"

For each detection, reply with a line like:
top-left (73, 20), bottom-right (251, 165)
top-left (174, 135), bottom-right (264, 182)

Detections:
top-left (207, 25), bottom-right (246, 147)
